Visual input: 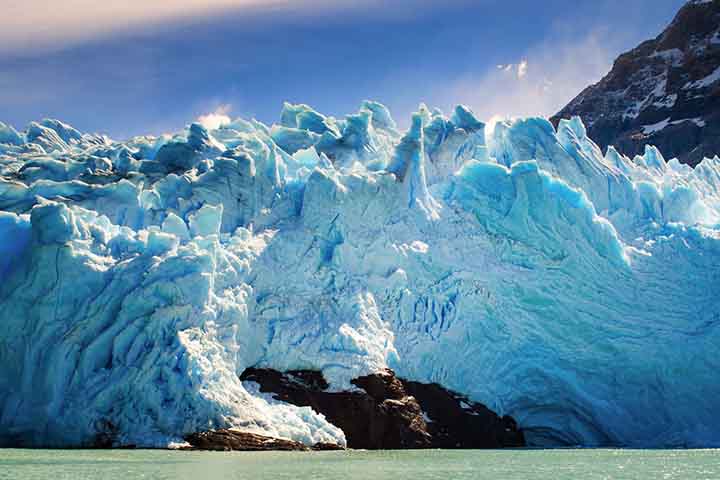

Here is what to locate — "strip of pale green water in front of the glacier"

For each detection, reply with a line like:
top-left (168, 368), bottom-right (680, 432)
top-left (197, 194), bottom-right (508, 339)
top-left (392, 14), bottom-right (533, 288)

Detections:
top-left (0, 450), bottom-right (720, 480)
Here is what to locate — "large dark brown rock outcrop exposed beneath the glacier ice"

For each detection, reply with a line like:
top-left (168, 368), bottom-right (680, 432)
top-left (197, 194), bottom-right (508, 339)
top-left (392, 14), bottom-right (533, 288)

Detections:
top-left (241, 368), bottom-right (525, 449)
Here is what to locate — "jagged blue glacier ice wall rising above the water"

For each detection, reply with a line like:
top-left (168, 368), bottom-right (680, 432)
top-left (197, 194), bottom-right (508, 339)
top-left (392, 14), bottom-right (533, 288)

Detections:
top-left (0, 102), bottom-right (720, 446)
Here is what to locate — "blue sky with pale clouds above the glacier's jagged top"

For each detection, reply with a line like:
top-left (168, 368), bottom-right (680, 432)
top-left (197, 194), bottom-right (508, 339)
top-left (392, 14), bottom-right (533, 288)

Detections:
top-left (0, 0), bottom-right (684, 139)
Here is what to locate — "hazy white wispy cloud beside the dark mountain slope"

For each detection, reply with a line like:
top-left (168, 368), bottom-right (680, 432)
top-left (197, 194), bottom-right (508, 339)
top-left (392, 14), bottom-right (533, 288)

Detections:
top-left (446, 31), bottom-right (617, 120)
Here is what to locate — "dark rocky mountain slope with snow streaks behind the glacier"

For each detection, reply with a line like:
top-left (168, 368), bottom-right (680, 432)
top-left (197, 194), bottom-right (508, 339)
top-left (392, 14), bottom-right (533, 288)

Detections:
top-left (552, 0), bottom-right (720, 165)
